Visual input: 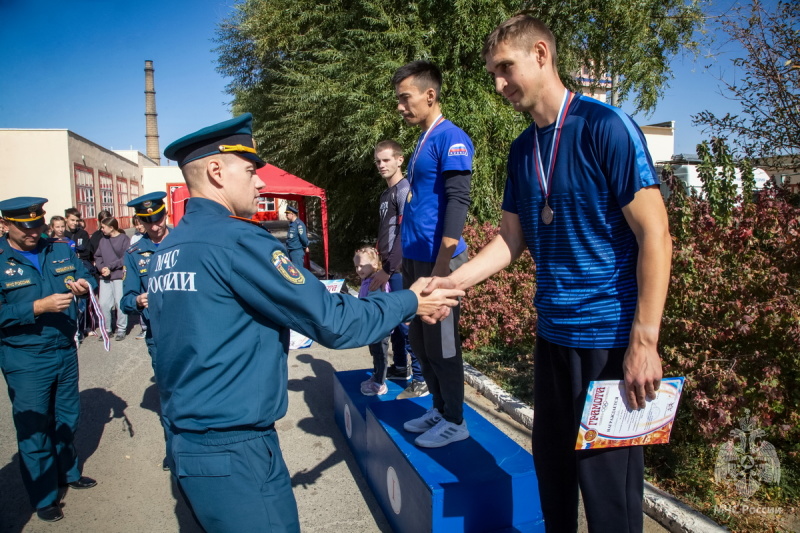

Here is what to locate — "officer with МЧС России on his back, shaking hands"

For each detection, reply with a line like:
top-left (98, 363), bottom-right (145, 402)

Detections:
top-left (148, 113), bottom-right (461, 532)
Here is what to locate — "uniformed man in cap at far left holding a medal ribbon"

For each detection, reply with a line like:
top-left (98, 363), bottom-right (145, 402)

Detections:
top-left (0, 197), bottom-right (97, 522)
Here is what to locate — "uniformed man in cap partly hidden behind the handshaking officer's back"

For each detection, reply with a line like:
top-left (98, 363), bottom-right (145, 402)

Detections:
top-left (120, 191), bottom-right (169, 470)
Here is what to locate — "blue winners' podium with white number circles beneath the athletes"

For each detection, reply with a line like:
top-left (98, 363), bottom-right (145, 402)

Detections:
top-left (334, 370), bottom-right (544, 533)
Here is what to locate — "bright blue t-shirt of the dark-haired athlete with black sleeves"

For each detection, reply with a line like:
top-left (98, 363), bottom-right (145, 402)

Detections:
top-left (400, 120), bottom-right (475, 263)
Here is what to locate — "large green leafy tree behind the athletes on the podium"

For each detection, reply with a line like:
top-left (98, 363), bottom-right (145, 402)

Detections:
top-left (217, 0), bottom-right (699, 268)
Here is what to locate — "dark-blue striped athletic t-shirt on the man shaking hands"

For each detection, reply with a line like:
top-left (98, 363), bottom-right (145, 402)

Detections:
top-left (503, 95), bottom-right (659, 348)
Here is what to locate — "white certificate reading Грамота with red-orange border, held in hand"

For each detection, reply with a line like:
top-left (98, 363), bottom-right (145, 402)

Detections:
top-left (575, 377), bottom-right (684, 450)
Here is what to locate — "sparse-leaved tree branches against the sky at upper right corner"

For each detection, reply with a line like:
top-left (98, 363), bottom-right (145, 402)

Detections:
top-left (692, 0), bottom-right (800, 167)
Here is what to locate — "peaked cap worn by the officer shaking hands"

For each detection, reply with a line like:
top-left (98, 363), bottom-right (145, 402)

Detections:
top-left (164, 113), bottom-right (266, 168)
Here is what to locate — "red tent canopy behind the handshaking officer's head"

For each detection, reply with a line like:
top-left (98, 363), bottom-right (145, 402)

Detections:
top-left (170, 163), bottom-right (328, 278)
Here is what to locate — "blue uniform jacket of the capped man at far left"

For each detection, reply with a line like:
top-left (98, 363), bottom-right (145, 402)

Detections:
top-left (0, 238), bottom-right (97, 351)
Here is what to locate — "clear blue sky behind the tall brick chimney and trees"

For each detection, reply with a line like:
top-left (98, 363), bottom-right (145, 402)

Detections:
top-left (0, 0), bottom-right (756, 161)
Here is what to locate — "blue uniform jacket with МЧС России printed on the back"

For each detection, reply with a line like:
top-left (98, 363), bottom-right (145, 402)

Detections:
top-left (147, 198), bottom-right (417, 431)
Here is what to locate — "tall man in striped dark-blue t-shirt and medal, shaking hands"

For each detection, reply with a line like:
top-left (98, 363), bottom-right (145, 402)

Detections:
top-left (430, 15), bottom-right (671, 532)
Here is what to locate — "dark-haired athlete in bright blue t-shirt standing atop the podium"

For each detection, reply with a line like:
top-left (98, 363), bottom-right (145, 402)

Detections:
top-left (392, 61), bottom-right (475, 448)
